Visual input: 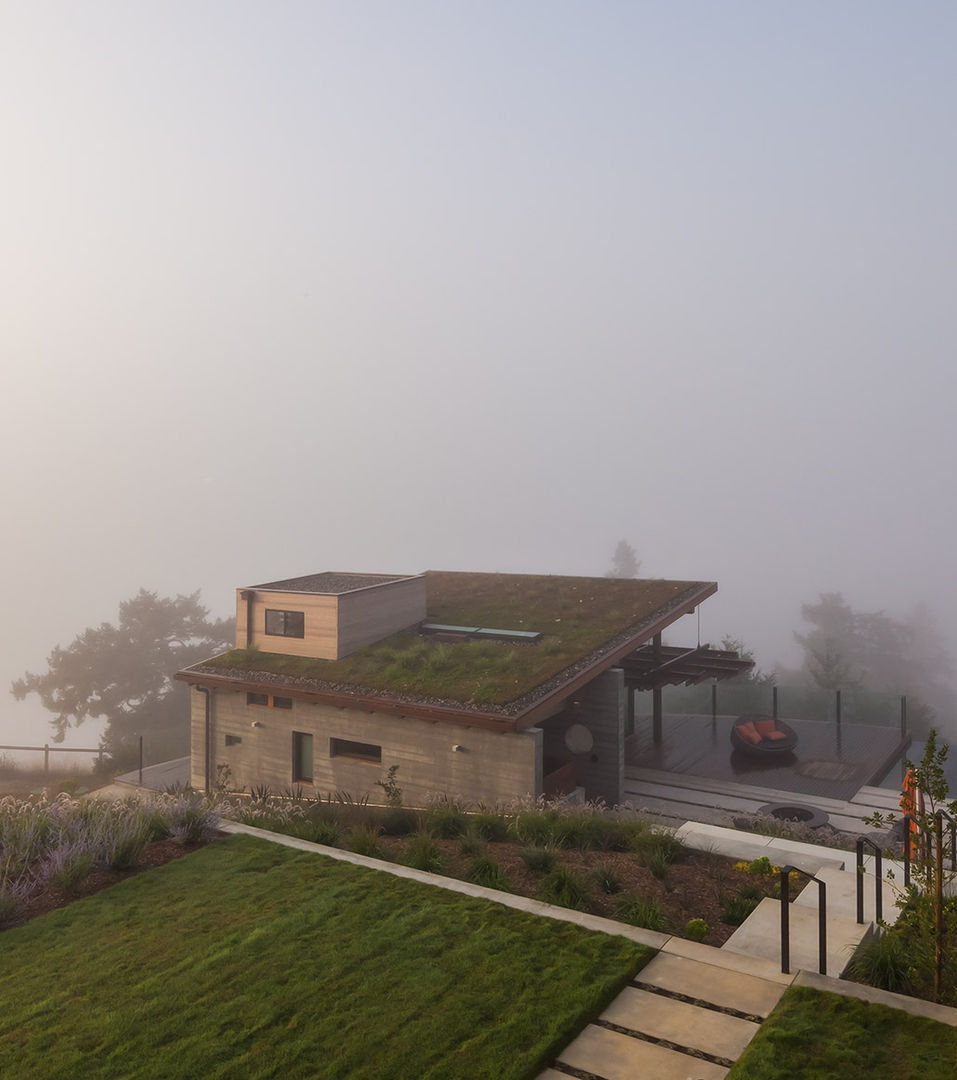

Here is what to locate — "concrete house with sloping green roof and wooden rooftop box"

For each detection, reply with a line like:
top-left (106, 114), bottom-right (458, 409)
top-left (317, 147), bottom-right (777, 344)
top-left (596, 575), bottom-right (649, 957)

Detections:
top-left (176, 571), bottom-right (750, 805)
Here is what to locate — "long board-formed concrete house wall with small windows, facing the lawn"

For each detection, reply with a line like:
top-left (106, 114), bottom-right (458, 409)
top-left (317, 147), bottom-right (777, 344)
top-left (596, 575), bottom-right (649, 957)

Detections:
top-left (190, 687), bottom-right (541, 806)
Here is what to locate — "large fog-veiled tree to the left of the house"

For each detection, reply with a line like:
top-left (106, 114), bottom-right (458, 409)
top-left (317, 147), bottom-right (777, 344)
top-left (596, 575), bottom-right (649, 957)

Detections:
top-left (12, 589), bottom-right (234, 767)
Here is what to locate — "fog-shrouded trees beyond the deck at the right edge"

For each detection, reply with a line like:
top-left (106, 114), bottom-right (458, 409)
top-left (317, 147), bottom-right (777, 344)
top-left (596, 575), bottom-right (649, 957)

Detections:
top-left (794, 593), bottom-right (957, 732)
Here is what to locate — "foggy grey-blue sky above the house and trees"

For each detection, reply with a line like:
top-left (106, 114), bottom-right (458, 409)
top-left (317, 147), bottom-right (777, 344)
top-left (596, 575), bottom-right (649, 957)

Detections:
top-left (0, 0), bottom-right (957, 741)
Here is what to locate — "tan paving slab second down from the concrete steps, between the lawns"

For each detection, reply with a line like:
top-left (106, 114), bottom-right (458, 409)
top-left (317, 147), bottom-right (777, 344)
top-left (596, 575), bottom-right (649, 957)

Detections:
top-left (602, 986), bottom-right (758, 1061)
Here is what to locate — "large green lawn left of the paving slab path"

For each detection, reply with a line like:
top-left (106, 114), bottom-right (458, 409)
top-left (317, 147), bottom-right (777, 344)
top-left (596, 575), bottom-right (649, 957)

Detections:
top-left (0, 836), bottom-right (650, 1080)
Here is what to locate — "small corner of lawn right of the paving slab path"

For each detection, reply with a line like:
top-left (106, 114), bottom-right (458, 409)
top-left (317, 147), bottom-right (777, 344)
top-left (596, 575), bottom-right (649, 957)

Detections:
top-left (728, 987), bottom-right (957, 1080)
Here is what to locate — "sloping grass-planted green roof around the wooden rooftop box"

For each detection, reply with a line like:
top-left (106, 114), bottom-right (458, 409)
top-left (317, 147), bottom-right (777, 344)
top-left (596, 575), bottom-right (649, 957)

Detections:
top-left (190, 570), bottom-right (715, 713)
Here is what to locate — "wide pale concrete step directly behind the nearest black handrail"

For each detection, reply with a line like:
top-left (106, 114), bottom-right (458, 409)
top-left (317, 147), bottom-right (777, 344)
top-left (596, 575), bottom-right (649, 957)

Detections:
top-left (723, 897), bottom-right (873, 978)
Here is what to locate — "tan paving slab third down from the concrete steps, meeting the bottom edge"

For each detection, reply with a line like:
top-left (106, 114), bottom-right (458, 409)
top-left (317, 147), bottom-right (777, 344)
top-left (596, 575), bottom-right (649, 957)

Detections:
top-left (558, 1024), bottom-right (728, 1080)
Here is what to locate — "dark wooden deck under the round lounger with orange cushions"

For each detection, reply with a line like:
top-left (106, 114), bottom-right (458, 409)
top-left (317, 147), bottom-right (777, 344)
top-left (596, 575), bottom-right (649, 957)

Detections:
top-left (625, 715), bottom-right (909, 800)
